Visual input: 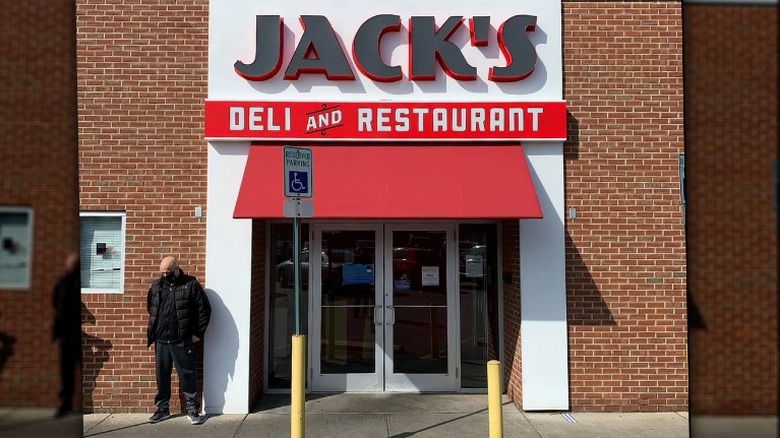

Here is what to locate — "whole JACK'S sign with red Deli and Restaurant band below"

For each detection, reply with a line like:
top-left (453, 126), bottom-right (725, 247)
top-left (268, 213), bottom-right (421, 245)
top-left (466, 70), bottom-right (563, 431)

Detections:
top-left (205, 0), bottom-right (566, 141)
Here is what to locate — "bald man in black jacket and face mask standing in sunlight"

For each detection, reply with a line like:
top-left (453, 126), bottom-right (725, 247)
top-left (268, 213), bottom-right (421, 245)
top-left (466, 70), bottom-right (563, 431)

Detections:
top-left (146, 256), bottom-right (211, 424)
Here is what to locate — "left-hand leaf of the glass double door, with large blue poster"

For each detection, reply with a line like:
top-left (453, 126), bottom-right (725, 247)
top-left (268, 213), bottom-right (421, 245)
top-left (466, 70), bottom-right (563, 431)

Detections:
top-left (309, 225), bottom-right (384, 391)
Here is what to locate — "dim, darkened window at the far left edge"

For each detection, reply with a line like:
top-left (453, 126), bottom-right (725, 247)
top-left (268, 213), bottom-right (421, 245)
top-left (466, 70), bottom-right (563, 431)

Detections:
top-left (0, 207), bottom-right (33, 289)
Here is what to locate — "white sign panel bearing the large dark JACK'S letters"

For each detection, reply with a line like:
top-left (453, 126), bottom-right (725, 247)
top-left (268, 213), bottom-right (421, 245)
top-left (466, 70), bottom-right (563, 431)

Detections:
top-left (208, 0), bottom-right (563, 101)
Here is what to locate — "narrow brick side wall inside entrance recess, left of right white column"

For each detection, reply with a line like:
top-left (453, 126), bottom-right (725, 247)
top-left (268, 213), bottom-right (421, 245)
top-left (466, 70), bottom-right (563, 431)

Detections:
top-left (501, 220), bottom-right (523, 408)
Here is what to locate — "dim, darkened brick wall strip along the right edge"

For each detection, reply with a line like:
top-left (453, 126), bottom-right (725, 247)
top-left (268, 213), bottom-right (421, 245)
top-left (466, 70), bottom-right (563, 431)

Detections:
top-left (684, 4), bottom-right (778, 415)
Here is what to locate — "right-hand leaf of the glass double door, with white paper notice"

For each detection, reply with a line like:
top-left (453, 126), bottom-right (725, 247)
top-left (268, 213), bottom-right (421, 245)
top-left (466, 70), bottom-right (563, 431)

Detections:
top-left (384, 225), bottom-right (457, 391)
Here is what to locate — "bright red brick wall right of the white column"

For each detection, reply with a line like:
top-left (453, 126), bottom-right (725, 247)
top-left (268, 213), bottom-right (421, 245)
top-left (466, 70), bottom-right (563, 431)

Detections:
top-left (563, 1), bottom-right (688, 411)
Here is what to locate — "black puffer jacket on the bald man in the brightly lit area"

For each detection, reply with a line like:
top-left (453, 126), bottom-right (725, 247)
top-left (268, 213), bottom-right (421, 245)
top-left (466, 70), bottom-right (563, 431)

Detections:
top-left (146, 268), bottom-right (211, 347)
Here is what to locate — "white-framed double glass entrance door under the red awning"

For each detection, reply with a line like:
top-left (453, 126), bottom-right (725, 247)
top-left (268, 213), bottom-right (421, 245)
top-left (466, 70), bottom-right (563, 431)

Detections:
top-left (309, 224), bottom-right (458, 391)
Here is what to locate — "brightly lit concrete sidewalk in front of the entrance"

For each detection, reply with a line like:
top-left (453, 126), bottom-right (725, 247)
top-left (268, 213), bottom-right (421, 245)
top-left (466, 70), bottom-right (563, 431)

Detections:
top-left (84, 393), bottom-right (688, 438)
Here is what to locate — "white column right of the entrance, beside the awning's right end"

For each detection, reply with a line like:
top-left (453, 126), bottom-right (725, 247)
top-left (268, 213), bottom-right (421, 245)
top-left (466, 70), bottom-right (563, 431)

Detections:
top-left (520, 143), bottom-right (569, 411)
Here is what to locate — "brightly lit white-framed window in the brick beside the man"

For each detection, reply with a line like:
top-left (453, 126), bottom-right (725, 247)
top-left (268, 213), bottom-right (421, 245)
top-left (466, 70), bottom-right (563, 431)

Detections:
top-left (79, 212), bottom-right (126, 293)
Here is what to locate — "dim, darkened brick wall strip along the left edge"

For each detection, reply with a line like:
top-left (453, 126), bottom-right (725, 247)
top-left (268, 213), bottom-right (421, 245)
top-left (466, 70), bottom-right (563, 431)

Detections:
top-left (0, 0), bottom-right (79, 408)
